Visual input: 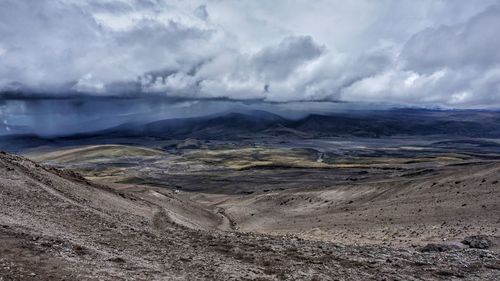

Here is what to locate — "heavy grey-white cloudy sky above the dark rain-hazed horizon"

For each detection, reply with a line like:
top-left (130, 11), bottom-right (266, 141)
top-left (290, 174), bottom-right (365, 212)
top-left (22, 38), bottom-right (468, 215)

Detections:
top-left (0, 0), bottom-right (500, 108)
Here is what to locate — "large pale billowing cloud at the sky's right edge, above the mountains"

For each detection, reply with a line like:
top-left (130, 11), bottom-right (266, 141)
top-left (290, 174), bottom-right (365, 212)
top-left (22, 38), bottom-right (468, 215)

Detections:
top-left (342, 6), bottom-right (500, 107)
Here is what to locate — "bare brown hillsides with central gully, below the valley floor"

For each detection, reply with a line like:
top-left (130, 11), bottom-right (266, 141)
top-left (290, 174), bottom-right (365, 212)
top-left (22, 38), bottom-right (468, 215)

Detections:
top-left (0, 153), bottom-right (500, 281)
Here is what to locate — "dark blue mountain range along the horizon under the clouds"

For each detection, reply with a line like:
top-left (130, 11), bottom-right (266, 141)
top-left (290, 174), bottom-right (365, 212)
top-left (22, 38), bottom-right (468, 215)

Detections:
top-left (0, 109), bottom-right (500, 149)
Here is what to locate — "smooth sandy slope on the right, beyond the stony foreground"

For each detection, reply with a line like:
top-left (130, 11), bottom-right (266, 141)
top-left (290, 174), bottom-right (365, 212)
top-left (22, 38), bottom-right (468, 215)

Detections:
top-left (190, 162), bottom-right (500, 247)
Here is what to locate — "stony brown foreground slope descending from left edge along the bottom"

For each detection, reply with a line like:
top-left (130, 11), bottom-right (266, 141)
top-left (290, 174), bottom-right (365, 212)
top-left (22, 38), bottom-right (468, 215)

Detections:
top-left (0, 153), bottom-right (500, 280)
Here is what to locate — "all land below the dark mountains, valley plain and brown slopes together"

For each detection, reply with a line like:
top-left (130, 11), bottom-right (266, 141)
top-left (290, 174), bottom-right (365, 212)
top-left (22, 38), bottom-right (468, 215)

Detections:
top-left (0, 135), bottom-right (500, 280)
